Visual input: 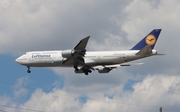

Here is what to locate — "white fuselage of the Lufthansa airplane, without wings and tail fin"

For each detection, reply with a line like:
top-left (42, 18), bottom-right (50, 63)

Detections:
top-left (16, 50), bottom-right (157, 67)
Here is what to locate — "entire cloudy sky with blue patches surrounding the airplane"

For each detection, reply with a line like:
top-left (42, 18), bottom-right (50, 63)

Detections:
top-left (0, 0), bottom-right (180, 112)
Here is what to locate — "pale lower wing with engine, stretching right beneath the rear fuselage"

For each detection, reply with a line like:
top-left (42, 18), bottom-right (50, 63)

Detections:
top-left (93, 63), bottom-right (143, 73)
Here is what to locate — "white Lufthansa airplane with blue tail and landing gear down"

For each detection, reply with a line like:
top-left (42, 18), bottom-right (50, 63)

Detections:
top-left (15, 29), bottom-right (163, 75)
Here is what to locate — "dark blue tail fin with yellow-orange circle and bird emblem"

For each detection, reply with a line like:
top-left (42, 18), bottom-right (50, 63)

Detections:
top-left (131, 29), bottom-right (161, 50)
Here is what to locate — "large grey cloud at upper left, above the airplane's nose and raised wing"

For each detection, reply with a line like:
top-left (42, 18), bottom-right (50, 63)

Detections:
top-left (0, 0), bottom-right (131, 54)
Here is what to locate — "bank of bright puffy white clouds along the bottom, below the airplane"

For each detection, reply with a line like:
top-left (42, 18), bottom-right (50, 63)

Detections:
top-left (1, 75), bottom-right (180, 112)
